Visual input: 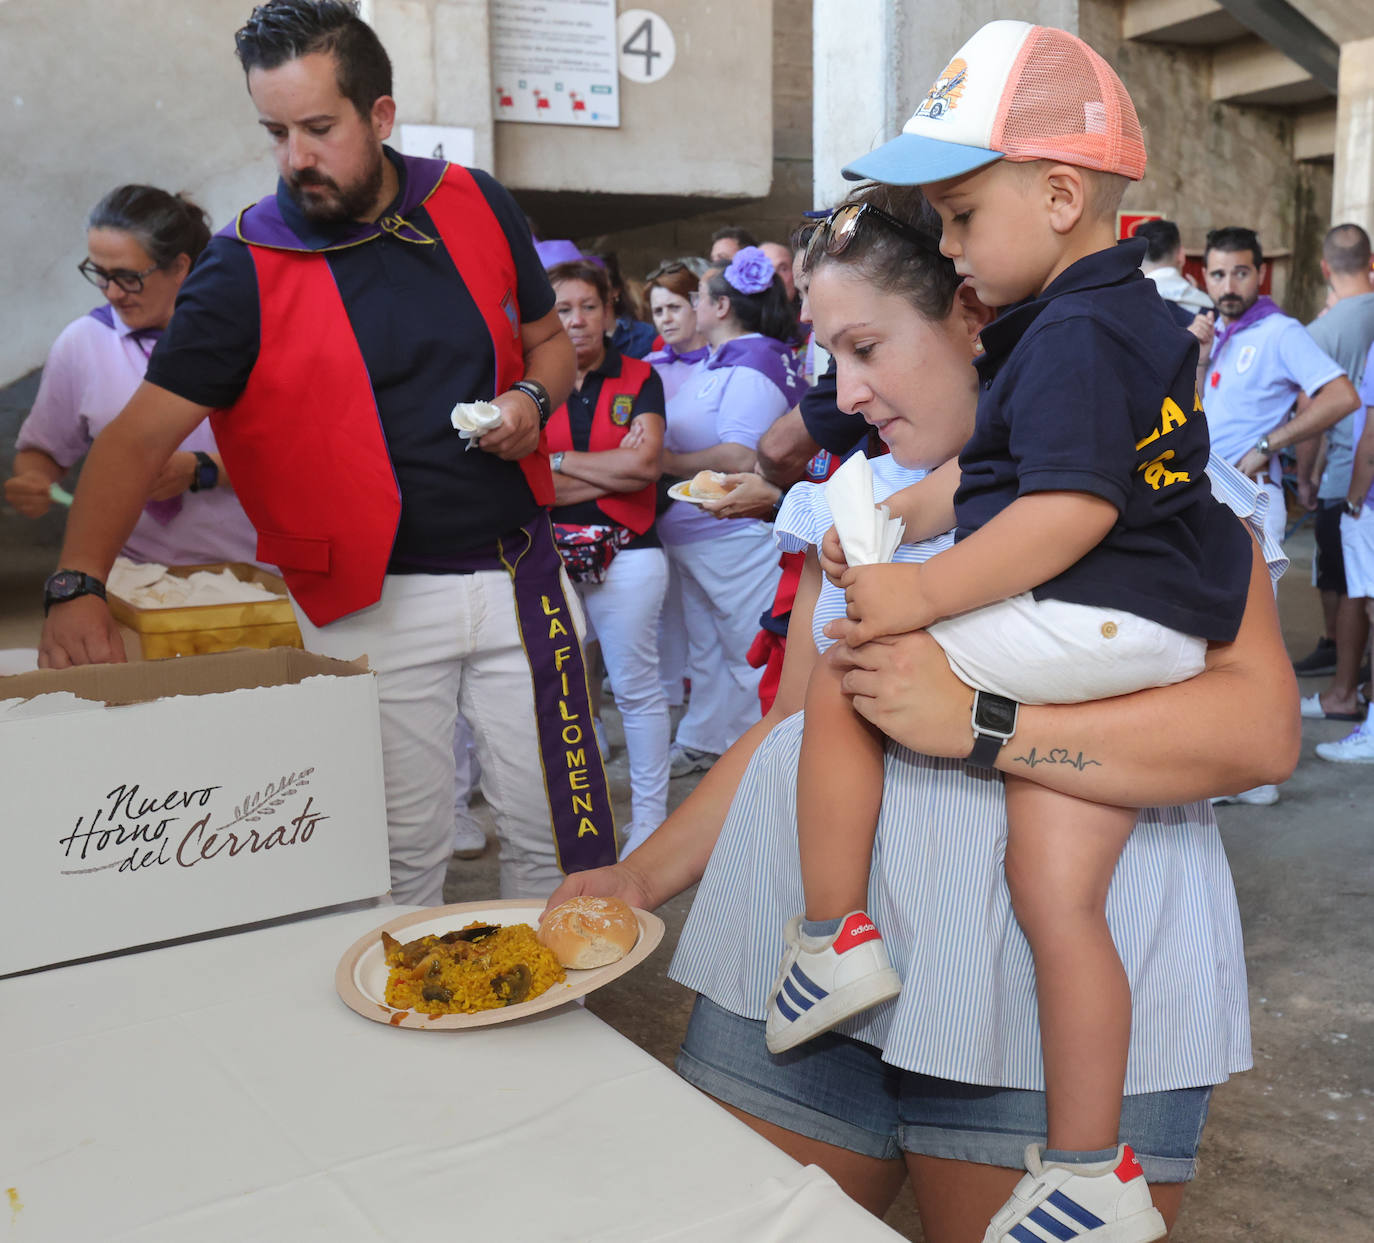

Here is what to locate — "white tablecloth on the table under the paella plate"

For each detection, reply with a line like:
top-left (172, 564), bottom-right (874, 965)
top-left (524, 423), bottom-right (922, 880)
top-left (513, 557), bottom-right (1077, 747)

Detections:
top-left (0, 908), bottom-right (897, 1243)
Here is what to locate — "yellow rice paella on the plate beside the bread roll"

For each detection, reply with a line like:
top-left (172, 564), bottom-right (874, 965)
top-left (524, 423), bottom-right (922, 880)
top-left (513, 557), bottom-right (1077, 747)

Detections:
top-left (382, 923), bottom-right (566, 1014)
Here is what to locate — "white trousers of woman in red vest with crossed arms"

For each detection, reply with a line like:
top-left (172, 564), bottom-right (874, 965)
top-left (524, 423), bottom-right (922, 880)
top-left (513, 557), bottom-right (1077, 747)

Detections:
top-left (576, 548), bottom-right (669, 845)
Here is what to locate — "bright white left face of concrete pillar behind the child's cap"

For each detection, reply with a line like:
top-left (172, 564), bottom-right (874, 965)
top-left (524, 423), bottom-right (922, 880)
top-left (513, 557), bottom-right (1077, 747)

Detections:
top-left (812, 0), bottom-right (907, 207)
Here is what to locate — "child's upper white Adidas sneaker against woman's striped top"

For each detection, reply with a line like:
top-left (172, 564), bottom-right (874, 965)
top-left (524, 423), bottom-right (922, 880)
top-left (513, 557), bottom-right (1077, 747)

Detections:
top-left (765, 911), bottom-right (901, 1053)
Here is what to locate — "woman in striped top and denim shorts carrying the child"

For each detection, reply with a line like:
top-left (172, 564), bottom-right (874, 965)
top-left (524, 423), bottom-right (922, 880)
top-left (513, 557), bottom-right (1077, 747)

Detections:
top-left (550, 179), bottom-right (1297, 1243)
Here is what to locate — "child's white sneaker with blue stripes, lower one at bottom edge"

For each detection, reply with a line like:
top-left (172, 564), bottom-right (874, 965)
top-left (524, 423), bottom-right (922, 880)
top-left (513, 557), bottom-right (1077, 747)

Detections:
top-left (982, 1144), bottom-right (1168, 1243)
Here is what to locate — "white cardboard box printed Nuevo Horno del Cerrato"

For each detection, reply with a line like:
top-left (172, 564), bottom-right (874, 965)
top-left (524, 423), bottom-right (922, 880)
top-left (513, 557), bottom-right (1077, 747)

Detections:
top-left (0, 648), bottom-right (390, 975)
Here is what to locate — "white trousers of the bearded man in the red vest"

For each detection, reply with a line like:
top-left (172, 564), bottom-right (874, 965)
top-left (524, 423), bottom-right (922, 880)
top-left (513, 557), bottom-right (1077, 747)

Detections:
top-left (295, 570), bottom-right (584, 906)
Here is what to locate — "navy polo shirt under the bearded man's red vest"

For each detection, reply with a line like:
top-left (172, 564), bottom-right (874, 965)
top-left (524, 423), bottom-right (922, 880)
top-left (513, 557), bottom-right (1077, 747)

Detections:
top-left (147, 148), bottom-right (554, 574)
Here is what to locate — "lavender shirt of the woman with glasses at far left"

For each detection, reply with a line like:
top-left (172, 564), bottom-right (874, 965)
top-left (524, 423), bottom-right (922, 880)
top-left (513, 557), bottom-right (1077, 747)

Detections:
top-left (15, 307), bottom-right (257, 566)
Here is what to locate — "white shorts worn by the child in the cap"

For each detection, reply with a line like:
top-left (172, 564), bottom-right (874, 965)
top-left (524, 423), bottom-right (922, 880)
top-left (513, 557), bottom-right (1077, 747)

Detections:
top-left (930, 593), bottom-right (1209, 703)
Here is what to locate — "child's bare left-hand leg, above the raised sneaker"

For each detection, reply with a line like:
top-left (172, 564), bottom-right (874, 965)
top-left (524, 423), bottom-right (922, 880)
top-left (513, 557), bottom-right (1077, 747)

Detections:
top-left (797, 659), bottom-right (882, 920)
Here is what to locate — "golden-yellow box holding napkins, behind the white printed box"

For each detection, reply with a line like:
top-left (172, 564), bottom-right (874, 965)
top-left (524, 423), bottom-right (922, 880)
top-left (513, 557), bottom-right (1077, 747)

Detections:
top-left (110, 562), bottom-right (302, 661)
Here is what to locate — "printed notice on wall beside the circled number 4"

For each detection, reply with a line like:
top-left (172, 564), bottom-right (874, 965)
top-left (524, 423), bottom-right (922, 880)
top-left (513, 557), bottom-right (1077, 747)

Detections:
top-left (491, 0), bottom-right (620, 128)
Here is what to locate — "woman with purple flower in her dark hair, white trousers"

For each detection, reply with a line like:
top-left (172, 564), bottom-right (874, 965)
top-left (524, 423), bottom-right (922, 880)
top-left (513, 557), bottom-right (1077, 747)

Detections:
top-left (658, 246), bottom-right (805, 777)
